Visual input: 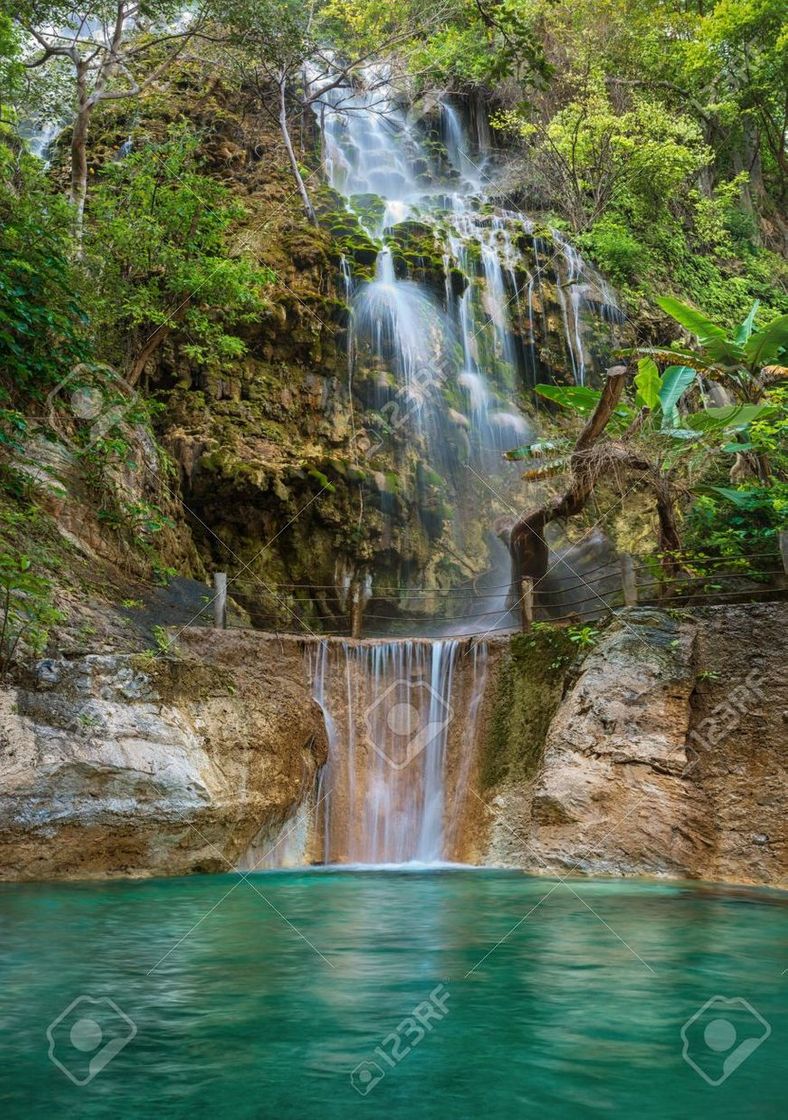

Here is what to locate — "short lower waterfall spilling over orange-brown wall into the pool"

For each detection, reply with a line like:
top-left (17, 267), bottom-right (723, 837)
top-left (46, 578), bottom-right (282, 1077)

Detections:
top-left (308, 638), bottom-right (488, 865)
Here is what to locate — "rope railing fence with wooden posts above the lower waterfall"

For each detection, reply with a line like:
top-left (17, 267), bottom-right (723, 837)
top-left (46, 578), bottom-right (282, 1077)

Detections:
top-left (200, 532), bottom-right (788, 638)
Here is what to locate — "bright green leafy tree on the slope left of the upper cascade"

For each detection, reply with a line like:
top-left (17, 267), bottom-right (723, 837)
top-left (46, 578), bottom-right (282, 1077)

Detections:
top-left (86, 128), bottom-right (273, 385)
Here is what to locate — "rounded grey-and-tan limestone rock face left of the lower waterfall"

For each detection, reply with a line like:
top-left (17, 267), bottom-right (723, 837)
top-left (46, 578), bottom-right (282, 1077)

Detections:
top-left (0, 632), bottom-right (326, 879)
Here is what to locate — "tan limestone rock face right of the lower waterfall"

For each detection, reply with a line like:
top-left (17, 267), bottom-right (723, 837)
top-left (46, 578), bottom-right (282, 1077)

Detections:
top-left (486, 604), bottom-right (788, 885)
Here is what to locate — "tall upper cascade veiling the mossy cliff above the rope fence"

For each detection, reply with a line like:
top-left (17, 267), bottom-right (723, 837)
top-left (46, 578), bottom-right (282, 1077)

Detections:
top-left (307, 65), bottom-right (619, 633)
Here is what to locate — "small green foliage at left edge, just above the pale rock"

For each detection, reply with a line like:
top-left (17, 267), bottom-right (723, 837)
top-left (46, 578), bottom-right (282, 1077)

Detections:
top-left (0, 552), bottom-right (64, 678)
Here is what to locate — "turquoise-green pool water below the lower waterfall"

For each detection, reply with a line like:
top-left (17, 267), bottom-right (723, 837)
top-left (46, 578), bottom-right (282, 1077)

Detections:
top-left (0, 869), bottom-right (788, 1120)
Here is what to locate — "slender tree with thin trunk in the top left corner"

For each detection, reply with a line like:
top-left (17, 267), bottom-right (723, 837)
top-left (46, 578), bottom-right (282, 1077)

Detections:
top-left (12, 0), bottom-right (210, 243)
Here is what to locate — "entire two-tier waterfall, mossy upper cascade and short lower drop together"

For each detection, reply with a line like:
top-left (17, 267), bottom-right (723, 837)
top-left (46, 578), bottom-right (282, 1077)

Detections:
top-left (258, 63), bottom-right (618, 865)
